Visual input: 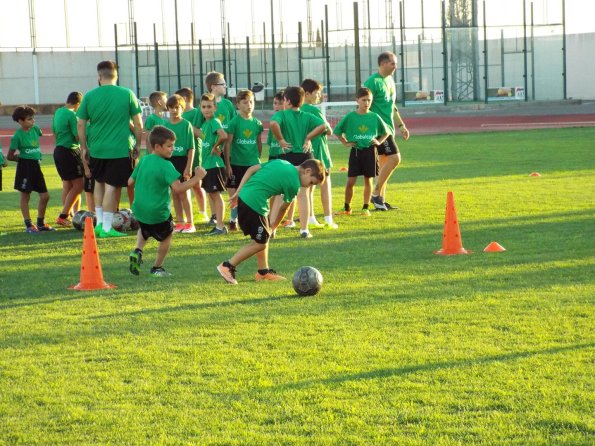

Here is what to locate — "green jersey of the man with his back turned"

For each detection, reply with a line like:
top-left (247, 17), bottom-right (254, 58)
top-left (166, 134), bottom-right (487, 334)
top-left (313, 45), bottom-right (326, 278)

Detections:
top-left (77, 85), bottom-right (141, 159)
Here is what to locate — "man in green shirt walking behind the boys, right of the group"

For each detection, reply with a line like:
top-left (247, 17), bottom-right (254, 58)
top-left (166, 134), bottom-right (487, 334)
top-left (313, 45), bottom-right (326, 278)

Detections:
top-left (364, 51), bottom-right (409, 211)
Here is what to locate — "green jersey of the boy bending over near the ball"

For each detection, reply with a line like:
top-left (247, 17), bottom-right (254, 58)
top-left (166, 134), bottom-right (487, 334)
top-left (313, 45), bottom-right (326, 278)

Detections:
top-left (239, 160), bottom-right (301, 217)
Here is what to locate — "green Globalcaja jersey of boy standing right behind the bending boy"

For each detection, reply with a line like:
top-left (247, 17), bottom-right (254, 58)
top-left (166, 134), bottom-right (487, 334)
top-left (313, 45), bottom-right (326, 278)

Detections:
top-left (227, 115), bottom-right (263, 166)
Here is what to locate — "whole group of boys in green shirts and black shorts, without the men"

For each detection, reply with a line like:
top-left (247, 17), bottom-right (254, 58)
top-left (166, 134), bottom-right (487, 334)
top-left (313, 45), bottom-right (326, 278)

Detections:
top-left (0, 72), bottom-right (396, 284)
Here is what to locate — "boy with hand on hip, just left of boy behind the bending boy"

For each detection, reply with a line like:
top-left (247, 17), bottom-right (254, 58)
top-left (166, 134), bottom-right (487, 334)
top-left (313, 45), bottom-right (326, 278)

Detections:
top-left (200, 93), bottom-right (227, 235)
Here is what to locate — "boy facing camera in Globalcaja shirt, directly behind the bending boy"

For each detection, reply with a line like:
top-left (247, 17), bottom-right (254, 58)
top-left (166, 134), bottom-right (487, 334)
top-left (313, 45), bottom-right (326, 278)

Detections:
top-left (224, 90), bottom-right (263, 231)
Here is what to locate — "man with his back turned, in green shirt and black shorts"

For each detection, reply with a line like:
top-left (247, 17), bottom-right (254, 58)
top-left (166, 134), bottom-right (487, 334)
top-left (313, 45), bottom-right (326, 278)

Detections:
top-left (77, 60), bottom-right (143, 238)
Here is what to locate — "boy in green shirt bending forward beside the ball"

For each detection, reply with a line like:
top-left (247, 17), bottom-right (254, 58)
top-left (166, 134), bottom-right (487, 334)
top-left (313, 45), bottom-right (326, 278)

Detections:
top-left (217, 159), bottom-right (325, 285)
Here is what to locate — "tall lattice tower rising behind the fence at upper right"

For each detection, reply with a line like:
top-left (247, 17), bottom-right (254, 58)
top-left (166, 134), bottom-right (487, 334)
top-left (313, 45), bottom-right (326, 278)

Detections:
top-left (446, 0), bottom-right (479, 101)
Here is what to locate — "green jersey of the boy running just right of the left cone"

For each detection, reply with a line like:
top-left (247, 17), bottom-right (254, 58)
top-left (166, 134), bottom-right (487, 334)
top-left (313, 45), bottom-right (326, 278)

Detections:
top-left (131, 153), bottom-right (180, 225)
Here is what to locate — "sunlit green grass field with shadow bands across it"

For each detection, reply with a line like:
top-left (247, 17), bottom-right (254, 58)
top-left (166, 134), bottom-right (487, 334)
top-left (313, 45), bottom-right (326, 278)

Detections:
top-left (0, 128), bottom-right (595, 445)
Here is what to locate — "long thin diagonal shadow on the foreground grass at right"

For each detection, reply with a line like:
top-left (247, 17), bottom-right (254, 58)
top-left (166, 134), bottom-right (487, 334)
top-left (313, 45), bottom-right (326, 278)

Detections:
top-left (268, 342), bottom-right (595, 391)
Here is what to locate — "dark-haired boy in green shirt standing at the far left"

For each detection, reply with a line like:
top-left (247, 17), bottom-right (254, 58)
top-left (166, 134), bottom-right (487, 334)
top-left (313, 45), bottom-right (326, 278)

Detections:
top-left (6, 105), bottom-right (54, 234)
